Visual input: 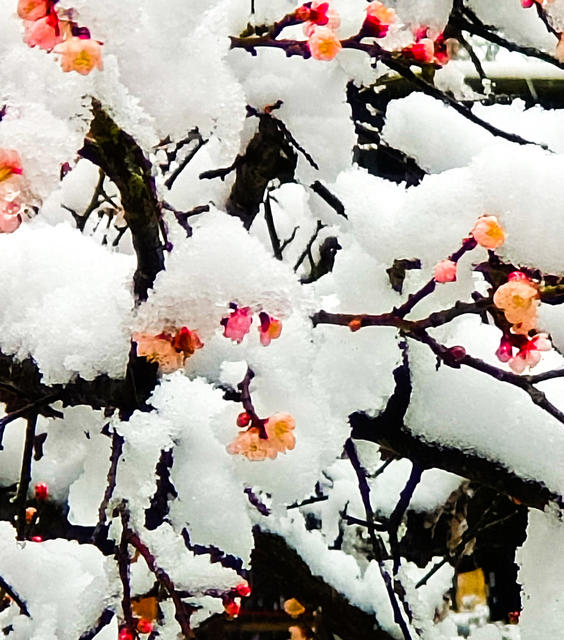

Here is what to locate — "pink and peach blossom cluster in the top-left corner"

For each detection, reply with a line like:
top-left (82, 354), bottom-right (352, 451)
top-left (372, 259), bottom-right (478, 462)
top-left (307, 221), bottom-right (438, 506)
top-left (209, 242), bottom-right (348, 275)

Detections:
top-left (18, 0), bottom-right (102, 75)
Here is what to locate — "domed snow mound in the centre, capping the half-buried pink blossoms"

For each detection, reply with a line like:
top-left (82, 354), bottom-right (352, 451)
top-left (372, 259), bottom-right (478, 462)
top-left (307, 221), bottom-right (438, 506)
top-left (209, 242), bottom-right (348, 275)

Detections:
top-left (138, 210), bottom-right (305, 341)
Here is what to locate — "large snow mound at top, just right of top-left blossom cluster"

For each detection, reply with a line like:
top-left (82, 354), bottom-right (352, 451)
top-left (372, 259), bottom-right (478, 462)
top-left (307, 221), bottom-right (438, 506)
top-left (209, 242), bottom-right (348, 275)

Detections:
top-left (70, 0), bottom-right (245, 155)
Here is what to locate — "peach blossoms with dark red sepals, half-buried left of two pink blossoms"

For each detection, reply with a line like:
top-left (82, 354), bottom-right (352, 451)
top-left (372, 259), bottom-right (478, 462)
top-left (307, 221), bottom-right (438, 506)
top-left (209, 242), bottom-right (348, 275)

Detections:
top-left (132, 327), bottom-right (204, 373)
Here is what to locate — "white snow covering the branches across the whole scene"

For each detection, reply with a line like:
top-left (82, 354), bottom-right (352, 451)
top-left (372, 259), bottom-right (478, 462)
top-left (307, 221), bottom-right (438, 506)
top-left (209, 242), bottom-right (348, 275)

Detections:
top-left (0, 0), bottom-right (564, 640)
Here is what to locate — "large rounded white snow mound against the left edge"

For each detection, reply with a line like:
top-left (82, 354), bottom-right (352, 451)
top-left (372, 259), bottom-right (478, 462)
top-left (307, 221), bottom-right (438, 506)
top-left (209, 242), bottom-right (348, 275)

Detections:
top-left (0, 220), bottom-right (133, 384)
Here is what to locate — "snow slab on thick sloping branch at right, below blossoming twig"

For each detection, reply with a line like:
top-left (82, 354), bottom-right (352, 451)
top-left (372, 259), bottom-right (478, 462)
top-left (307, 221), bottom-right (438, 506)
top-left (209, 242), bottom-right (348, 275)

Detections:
top-left (405, 318), bottom-right (564, 494)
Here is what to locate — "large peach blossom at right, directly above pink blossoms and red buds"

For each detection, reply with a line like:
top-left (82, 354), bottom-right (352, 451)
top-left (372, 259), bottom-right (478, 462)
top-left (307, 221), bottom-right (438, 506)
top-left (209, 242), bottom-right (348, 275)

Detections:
top-left (493, 271), bottom-right (539, 335)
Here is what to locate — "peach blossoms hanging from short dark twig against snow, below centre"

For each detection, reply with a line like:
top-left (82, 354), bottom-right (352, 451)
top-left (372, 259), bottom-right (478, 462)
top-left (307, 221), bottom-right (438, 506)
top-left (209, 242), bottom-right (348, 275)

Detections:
top-left (227, 411), bottom-right (296, 461)
